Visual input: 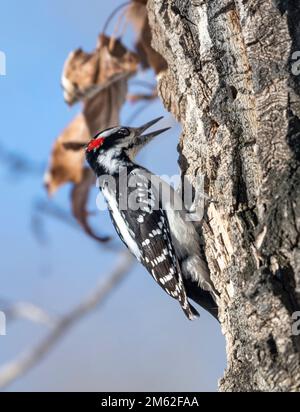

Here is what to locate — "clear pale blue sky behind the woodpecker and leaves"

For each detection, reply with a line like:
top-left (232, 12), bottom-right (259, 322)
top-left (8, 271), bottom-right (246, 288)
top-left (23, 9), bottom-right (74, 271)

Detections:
top-left (0, 0), bottom-right (225, 391)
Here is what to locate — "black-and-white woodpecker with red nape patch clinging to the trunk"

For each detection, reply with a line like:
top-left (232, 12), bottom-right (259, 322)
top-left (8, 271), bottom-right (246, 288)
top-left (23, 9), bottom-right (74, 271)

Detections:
top-left (85, 117), bottom-right (218, 319)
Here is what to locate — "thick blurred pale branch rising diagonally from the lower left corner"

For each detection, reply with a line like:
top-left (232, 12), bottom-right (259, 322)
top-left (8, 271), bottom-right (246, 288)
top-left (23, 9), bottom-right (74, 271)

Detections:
top-left (0, 252), bottom-right (133, 388)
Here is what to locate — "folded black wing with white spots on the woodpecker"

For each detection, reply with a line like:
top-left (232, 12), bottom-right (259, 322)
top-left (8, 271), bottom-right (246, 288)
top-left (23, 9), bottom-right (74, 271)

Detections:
top-left (104, 171), bottom-right (197, 318)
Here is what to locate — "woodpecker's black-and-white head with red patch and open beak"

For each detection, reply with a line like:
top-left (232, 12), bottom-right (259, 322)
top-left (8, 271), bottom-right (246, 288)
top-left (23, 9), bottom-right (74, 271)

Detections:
top-left (85, 117), bottom-right (169, 174)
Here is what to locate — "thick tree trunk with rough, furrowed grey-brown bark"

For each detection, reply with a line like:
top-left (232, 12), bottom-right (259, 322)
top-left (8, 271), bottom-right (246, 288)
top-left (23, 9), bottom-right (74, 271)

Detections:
top-left (148, 0), bottom-right (300, 391)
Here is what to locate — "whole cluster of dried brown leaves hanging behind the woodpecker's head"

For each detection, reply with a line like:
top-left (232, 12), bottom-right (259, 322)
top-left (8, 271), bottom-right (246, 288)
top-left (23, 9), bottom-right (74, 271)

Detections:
top-left (44, 0), bottom-right (166, 242)
